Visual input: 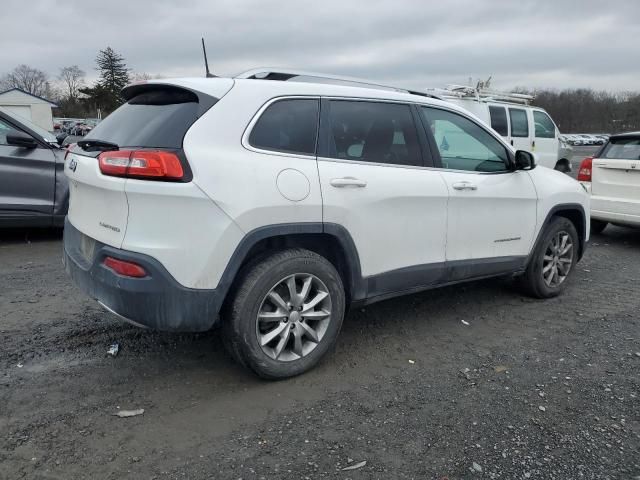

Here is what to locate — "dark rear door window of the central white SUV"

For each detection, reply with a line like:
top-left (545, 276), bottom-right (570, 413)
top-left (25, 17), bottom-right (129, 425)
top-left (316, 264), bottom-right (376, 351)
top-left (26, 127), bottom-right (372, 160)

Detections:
top-left (329, 100), bottom-right (422, 166)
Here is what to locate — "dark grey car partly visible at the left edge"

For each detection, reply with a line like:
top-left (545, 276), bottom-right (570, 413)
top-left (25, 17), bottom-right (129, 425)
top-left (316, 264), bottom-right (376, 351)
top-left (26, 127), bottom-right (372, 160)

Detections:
top-left (0, 108), bottom-right (69, 227)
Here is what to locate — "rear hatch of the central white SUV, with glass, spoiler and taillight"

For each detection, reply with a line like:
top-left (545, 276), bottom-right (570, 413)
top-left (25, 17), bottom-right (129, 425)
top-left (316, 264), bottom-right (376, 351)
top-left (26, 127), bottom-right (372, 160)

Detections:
top-left (65, 79), bottom-right (233, 248)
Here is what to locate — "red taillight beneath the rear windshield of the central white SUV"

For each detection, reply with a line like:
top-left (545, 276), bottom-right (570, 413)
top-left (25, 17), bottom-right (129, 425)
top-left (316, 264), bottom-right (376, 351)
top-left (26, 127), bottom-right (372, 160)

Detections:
top-left (98, 150), bottom-right (184, 180)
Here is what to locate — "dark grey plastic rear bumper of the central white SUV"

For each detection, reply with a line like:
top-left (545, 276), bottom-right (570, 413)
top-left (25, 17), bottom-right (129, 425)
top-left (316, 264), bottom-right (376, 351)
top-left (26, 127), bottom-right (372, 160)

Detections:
top-left (63, 220), bottom-right (222, 332)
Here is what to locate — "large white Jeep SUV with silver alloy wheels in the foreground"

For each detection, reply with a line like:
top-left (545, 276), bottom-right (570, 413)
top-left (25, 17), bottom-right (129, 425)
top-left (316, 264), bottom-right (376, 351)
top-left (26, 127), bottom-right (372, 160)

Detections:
top-left (64, 70), bottom-right (589, 378)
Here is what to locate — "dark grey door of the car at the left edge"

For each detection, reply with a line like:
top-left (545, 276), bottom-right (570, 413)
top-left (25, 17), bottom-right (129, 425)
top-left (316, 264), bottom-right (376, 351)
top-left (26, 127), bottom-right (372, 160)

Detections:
top-left (0, 117), bottom-right (56, 217)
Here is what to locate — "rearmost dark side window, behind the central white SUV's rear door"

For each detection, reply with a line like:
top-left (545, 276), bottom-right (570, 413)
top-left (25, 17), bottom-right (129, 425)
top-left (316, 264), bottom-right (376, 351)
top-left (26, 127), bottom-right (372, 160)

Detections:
top-left (249, 98), bottom-right (319, 155)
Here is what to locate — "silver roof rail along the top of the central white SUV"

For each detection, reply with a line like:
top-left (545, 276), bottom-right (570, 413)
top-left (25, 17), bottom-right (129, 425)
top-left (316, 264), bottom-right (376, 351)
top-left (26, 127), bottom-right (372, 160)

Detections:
top-left (234, 68), bottom-right (441, 100)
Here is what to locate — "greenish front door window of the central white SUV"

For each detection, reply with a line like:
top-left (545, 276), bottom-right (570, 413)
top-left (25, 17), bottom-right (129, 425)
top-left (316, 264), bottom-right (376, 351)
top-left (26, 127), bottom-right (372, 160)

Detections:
top-left (422, 107), bottom-right (508, 172)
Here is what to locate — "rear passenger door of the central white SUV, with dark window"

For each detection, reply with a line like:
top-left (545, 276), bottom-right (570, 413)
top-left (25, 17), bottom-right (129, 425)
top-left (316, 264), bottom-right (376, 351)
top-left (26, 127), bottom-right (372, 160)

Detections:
top-left (318, 99), bottom-right (448, 297)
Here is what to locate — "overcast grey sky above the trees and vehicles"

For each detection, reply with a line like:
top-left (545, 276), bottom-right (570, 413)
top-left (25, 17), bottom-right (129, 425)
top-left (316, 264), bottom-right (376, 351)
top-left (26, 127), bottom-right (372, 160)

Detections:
top-left (0, 0), bottom-right (640, 90)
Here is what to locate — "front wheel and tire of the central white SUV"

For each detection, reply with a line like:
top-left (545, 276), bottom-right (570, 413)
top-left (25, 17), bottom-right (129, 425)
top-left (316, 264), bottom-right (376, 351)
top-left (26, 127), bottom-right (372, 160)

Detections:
top-left (519, 217), bottom-right (579, 298)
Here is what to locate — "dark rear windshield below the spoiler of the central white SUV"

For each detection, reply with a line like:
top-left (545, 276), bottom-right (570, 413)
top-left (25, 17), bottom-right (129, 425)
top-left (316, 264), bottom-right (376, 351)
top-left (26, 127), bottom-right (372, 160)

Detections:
top-left (84, 88), bottom-right (199, 148)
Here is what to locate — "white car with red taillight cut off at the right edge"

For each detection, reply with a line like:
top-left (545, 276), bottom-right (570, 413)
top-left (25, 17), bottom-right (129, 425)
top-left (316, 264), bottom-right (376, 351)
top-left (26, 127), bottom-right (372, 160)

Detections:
top-left (578, 132), bottom-right (640, 233)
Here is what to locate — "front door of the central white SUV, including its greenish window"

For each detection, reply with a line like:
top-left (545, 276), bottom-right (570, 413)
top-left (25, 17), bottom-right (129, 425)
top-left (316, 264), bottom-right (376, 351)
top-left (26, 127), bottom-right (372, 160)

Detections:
top-left (420, 107), bottom-right (537, 280)
